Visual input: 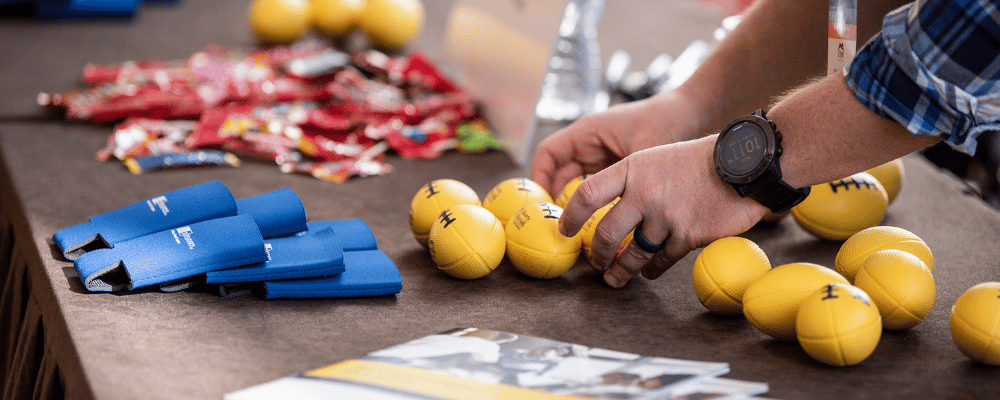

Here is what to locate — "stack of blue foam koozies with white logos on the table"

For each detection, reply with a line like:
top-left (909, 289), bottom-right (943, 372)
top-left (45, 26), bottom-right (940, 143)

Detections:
top-left (52, 181), bottom-right (402, 299)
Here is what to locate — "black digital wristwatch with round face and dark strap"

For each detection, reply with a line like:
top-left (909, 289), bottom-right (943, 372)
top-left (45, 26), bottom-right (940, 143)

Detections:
top-left (713, 110), bottom-right (809, 214)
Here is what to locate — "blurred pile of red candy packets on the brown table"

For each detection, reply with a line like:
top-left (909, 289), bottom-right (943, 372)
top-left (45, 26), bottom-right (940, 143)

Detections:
top-left (38, 41), bottom-right (501, 182)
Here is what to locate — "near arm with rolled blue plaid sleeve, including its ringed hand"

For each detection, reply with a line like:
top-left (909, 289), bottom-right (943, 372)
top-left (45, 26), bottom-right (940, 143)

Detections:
top-left (560, 0), bottom-right (1000, 287)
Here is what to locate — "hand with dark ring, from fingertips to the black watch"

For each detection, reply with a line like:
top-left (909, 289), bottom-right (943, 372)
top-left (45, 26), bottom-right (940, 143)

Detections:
top-left (559, 135), bottom-right (767, 287)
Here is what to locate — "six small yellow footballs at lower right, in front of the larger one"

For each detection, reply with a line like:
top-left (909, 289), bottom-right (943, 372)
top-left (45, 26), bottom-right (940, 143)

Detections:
top-left (692, 226), bottom-right (1000, 366)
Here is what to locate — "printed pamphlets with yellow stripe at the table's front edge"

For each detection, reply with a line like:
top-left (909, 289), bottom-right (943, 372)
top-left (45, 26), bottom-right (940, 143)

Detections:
top-left (224, 328), bottom-right (768, 400)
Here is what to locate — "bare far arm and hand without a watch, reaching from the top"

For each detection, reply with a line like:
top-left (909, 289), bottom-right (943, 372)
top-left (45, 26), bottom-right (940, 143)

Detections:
top-left (531, 0), bottom-right (904, 193)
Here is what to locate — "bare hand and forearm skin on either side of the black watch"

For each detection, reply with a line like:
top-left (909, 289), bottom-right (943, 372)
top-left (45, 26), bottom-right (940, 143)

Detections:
top-left (560, 75), bottom-right (940, 287)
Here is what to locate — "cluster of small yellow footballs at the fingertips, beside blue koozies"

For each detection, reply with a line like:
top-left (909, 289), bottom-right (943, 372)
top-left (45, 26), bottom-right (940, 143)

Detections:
top-left (410, 177), bottom-right (608, 279)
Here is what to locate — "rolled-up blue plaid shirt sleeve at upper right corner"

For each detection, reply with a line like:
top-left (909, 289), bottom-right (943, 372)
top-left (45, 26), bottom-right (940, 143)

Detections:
top-left (844, 0), bottom-right (1000, 154)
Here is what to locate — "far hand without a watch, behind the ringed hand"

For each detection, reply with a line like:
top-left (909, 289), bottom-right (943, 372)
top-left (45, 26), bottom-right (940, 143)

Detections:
top-left (531, 91), bottom-right (704, 197)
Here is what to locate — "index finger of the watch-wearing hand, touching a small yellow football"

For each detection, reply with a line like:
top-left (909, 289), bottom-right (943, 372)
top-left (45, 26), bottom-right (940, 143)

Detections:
top-left (559, 162), bottom-right (625, 239)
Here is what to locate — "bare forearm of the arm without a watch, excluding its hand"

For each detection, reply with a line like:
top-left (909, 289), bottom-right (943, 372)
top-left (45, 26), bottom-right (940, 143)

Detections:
top-left (676, 0), bottom-right (908, 134)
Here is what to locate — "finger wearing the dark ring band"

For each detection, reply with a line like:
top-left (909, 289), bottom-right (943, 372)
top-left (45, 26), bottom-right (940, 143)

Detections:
top-left (604, 221), bottom-right (668, 288)
